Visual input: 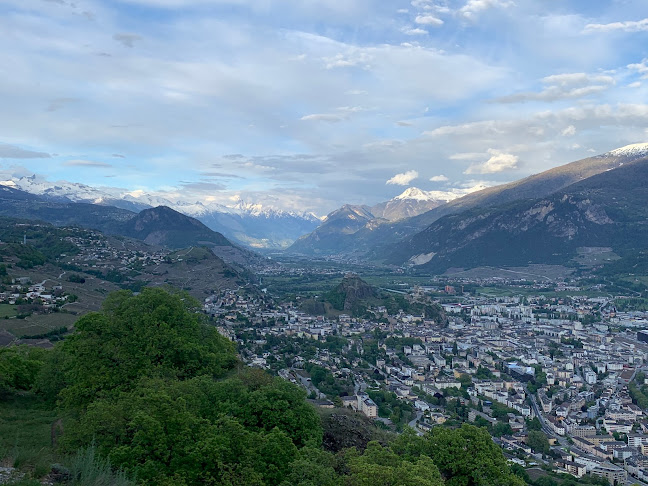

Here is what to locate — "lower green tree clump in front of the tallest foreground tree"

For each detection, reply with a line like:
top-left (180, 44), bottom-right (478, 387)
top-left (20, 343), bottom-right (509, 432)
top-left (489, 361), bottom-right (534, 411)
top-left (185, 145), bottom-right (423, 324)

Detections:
top-left (63, 375), bottom-right (321, 486)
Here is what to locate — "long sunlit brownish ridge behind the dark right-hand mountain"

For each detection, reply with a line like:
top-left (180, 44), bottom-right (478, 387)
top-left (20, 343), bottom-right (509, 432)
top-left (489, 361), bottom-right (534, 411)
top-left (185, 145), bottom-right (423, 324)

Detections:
top-left (289, 144), bottom-right (648, 260)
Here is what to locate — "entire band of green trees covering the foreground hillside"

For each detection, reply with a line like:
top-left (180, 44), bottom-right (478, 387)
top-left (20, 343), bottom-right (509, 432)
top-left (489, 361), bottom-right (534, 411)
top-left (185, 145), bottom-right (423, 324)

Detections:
top-left (0, 289), bottom-right (596, 486)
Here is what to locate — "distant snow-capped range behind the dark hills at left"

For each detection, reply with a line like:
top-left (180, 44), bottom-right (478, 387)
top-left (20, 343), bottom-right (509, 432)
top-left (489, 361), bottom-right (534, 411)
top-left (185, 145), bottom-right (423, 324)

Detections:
top-left (0, 176), bottom-right (321, 249)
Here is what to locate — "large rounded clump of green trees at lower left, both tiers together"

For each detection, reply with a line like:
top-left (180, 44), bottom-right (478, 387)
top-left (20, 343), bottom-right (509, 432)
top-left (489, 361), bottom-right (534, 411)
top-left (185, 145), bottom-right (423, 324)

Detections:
top-left (52, 289), bottom-right (322, 486)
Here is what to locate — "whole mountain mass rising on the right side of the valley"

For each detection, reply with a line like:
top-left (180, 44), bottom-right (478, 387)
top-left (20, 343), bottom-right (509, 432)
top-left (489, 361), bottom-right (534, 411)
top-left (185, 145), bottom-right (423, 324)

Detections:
top-left (289, 144), bottom-right (648, 272)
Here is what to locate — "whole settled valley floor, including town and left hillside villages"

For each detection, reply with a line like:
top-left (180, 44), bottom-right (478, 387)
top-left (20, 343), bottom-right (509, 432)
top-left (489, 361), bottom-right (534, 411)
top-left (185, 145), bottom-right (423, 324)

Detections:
top-left (0, 224), bottom-right (648, 484)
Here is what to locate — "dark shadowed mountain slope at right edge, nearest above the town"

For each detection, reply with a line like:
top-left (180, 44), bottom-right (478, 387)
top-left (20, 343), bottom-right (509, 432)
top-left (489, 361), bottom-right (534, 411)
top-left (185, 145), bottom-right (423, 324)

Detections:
top-left (387, 150), bottom-right (648, 272)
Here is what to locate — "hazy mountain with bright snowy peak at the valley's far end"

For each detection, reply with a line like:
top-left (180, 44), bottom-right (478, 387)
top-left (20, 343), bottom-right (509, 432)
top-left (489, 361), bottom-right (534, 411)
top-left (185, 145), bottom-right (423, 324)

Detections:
top-left (288, 187), bottom-right (459, 255)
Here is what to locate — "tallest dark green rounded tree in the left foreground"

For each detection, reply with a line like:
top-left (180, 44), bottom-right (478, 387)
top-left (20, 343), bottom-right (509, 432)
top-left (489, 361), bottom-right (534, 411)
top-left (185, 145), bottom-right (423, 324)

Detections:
top-left (61, 288), bottom-right (237, 408)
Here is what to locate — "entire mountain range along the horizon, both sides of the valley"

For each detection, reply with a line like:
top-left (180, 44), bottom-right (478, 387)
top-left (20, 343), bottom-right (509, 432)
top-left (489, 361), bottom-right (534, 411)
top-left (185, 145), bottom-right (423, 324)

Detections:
top-left (0, 144), bottom-right (648, 272)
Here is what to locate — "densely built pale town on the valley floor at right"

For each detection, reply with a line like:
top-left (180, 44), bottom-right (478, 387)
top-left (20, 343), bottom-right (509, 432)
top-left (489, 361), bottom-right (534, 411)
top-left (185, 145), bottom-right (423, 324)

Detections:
top-left (213, 271), bottom-right (648, 484)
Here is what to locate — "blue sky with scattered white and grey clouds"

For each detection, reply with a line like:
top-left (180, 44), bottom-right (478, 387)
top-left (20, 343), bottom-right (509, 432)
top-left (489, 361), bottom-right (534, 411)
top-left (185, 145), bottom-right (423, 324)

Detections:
top-left (0, 0), bottom-right (648, 215)
